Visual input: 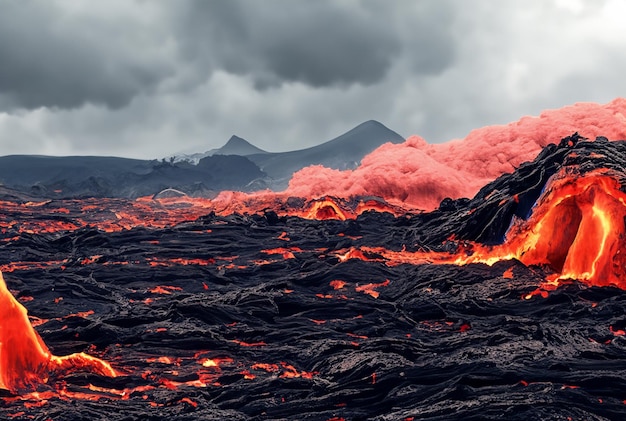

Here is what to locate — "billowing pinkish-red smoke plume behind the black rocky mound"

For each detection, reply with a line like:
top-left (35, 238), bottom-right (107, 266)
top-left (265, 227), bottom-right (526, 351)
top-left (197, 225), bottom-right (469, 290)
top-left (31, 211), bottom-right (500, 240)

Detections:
top-left (285, 98), bottom-right (626, 210)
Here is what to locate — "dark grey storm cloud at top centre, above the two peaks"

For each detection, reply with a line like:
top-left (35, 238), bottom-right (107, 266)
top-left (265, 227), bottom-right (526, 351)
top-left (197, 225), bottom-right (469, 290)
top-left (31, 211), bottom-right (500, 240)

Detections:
top-left (174, 0), bottom-right (454, 87)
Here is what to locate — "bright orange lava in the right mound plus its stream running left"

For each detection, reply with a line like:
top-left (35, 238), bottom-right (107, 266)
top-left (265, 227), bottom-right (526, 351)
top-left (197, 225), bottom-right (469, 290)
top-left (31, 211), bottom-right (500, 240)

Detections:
top-left (336, 171), bottom-right (626, 292)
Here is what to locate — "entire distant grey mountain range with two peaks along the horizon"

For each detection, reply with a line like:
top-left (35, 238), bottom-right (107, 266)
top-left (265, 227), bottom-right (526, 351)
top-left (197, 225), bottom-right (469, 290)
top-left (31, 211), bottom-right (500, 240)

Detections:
top-left (0, 121), bottom-right (404, 198)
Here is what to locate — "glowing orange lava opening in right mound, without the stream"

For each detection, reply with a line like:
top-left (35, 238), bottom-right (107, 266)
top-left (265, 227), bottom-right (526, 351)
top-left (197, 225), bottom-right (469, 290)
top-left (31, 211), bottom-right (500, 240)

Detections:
top-left (492, 173), bottom-right (626, 289)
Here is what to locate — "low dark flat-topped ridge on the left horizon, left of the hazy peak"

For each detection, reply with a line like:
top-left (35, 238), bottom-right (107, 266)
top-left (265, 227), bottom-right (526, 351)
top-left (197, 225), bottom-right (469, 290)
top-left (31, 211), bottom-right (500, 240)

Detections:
top-left (0, 155), bottom-right (266, 198)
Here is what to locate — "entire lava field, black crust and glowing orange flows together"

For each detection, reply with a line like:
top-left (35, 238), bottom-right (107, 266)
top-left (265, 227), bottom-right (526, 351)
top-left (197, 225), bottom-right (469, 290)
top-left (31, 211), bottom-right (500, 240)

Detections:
top-left (0, 102), bottom-right (626, 421)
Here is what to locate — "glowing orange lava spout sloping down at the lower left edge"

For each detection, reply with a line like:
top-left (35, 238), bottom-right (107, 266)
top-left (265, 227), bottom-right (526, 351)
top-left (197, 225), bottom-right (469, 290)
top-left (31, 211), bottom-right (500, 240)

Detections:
top-left (0, 273), bottom-right (117, 393)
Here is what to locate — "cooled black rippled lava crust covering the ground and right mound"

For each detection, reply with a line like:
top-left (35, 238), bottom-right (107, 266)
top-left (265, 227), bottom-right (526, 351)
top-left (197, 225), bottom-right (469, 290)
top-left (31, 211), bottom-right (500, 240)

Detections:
top-left (0, 135), bottom-right (626, 421)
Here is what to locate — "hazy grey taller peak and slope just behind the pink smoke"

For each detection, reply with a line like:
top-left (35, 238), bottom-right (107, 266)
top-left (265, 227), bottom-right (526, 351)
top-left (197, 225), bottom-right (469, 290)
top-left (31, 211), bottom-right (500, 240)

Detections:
top-left (248, 120), bottom-right (404, 190)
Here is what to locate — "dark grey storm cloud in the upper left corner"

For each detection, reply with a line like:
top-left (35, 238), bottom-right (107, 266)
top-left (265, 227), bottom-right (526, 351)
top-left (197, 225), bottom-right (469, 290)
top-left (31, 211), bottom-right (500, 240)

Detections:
top-left (0, 0), bottom-right (169, 110)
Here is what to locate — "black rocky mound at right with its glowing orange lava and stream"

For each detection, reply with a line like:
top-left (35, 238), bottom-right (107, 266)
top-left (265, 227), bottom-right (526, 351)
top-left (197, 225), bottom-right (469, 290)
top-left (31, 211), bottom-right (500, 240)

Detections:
top-left (351, 135), bottom-right (626, 289)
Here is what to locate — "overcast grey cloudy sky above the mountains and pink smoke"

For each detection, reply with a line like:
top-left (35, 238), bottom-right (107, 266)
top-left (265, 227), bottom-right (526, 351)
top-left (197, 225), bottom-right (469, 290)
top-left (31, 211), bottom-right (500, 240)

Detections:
top-left (0, 0), bottom-right (626, 158)
